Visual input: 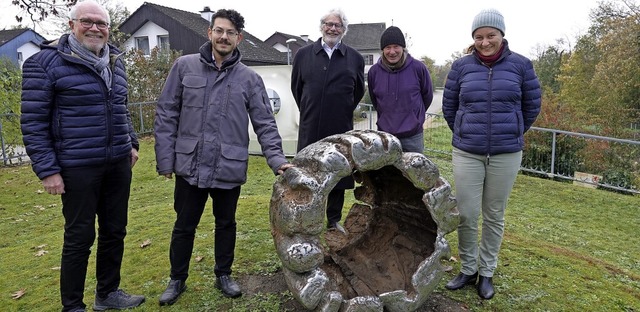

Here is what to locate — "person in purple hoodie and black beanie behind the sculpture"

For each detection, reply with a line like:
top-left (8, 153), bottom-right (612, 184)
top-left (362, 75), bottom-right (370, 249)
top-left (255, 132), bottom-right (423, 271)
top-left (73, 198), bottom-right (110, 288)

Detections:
top-left (367, 26), bottom-right (433, 153)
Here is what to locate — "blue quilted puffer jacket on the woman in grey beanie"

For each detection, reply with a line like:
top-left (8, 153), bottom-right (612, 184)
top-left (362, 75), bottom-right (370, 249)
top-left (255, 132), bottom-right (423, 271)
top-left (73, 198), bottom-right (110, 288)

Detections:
top-left (442, 40), bottom-right (541, 156)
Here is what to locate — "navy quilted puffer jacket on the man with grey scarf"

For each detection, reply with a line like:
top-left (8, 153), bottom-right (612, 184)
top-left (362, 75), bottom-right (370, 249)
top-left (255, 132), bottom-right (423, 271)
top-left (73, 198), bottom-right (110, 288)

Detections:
top-left (20, 35), bottom-right (139, 179)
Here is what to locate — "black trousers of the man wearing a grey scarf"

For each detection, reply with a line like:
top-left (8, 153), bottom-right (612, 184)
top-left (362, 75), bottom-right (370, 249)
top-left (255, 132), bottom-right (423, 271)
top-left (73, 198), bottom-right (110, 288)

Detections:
top-left (60, 158), bottom-right (131, 311)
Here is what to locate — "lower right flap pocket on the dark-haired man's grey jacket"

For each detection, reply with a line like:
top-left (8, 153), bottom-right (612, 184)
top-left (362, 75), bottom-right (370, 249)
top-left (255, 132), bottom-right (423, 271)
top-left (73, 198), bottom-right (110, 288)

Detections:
top-left (216, 144), bottom-right (249, 184)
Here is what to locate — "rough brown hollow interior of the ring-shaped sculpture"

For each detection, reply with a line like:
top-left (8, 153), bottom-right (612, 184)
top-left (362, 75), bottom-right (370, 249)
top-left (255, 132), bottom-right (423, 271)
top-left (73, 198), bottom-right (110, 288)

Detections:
top-left (321, 166), bottom-right (437, 299)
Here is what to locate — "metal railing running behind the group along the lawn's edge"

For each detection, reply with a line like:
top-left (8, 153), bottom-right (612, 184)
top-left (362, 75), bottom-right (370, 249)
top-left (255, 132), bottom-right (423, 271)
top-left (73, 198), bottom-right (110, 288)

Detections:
top-left (0, 106), bottom-right (640, 194)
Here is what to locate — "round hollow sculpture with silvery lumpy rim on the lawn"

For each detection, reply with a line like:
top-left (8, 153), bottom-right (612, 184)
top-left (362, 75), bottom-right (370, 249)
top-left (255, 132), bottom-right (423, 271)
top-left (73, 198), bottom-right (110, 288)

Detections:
top-left (270, 130), bottom-right (459, 312)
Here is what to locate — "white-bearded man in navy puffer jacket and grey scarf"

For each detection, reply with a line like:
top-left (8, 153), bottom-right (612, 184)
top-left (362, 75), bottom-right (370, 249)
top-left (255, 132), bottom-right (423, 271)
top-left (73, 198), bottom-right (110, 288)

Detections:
top-left (20, 0), bottom-right (144, 311)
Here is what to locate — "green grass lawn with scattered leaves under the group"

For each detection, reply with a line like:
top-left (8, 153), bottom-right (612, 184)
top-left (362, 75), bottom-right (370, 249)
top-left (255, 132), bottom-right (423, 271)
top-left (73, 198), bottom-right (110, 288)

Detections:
top-left (0, 139), bottom-right (640, 311)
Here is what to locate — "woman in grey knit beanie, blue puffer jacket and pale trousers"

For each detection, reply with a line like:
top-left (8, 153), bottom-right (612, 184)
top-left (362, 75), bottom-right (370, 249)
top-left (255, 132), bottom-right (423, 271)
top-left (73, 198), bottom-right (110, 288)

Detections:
top-left (442, 9), bottom-right (541, 299)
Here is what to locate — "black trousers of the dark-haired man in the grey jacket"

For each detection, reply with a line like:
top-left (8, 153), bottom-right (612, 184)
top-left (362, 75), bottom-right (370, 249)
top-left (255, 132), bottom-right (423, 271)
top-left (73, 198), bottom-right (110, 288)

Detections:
top-left (169, 176), bottom-right (240, 281)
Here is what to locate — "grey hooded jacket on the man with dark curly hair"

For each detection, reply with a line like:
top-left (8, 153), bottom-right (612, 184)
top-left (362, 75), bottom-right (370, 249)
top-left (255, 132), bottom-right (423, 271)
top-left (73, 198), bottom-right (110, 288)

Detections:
top-left (155, 42), bottom-right (287, 189)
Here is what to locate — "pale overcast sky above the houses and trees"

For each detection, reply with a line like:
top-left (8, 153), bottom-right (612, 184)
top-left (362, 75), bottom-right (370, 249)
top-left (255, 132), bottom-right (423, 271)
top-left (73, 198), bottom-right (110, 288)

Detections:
top-left (0, 0), bottom-right (598, 64)
